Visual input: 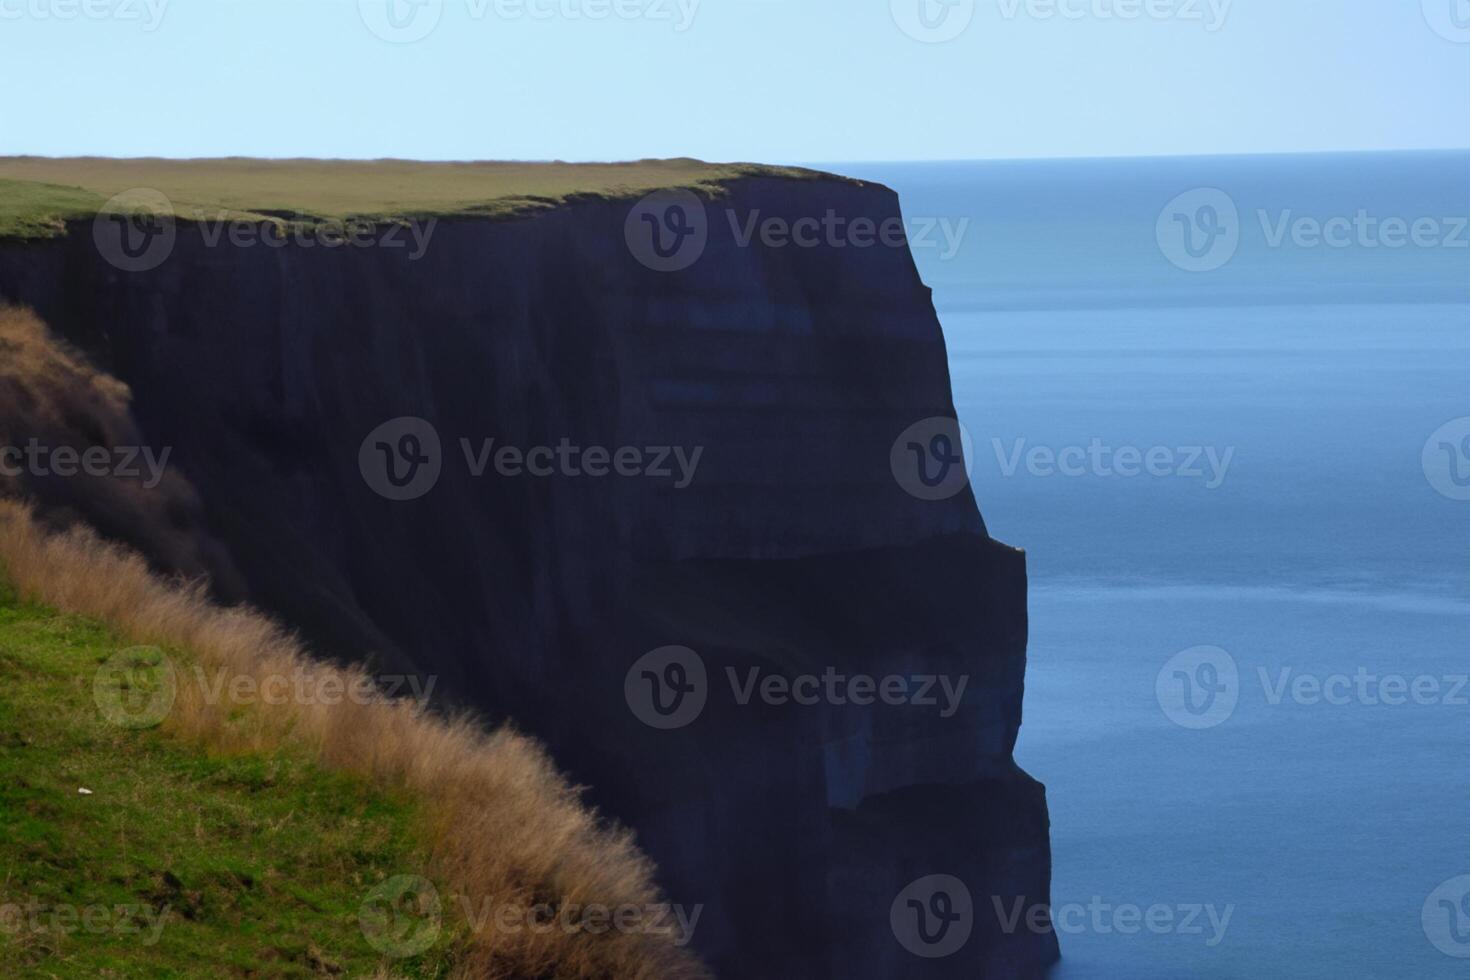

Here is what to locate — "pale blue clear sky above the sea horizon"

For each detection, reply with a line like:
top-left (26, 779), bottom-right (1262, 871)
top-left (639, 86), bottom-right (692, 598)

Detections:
top-left (0, 0), bottom-right (1470, 163)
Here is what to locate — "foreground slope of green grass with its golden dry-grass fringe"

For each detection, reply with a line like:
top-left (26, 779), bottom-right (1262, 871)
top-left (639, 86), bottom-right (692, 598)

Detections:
top-left (0, 501), bottom-right (704, 980)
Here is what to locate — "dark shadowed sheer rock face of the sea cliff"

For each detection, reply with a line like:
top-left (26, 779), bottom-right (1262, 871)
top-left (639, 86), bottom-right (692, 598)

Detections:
top-left (0, 179), bottom-right (1055, 979)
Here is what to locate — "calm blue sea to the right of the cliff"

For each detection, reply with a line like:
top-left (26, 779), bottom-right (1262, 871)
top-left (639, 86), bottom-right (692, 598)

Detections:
top-left (835, 153), bottom-right (1470, 980)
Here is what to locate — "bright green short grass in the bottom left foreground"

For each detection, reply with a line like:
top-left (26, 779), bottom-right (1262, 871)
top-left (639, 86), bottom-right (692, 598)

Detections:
top-left (0, 582), bottom-right (453, 980)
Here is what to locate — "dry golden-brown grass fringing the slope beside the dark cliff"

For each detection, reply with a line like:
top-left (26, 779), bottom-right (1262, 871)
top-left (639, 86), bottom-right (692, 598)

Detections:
top-left (0, 313), bottom-right (707, 980)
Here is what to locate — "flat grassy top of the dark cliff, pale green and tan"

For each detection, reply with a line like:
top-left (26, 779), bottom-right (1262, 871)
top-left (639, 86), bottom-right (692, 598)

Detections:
top-left (0, 157), bottom-right (826, 238)
